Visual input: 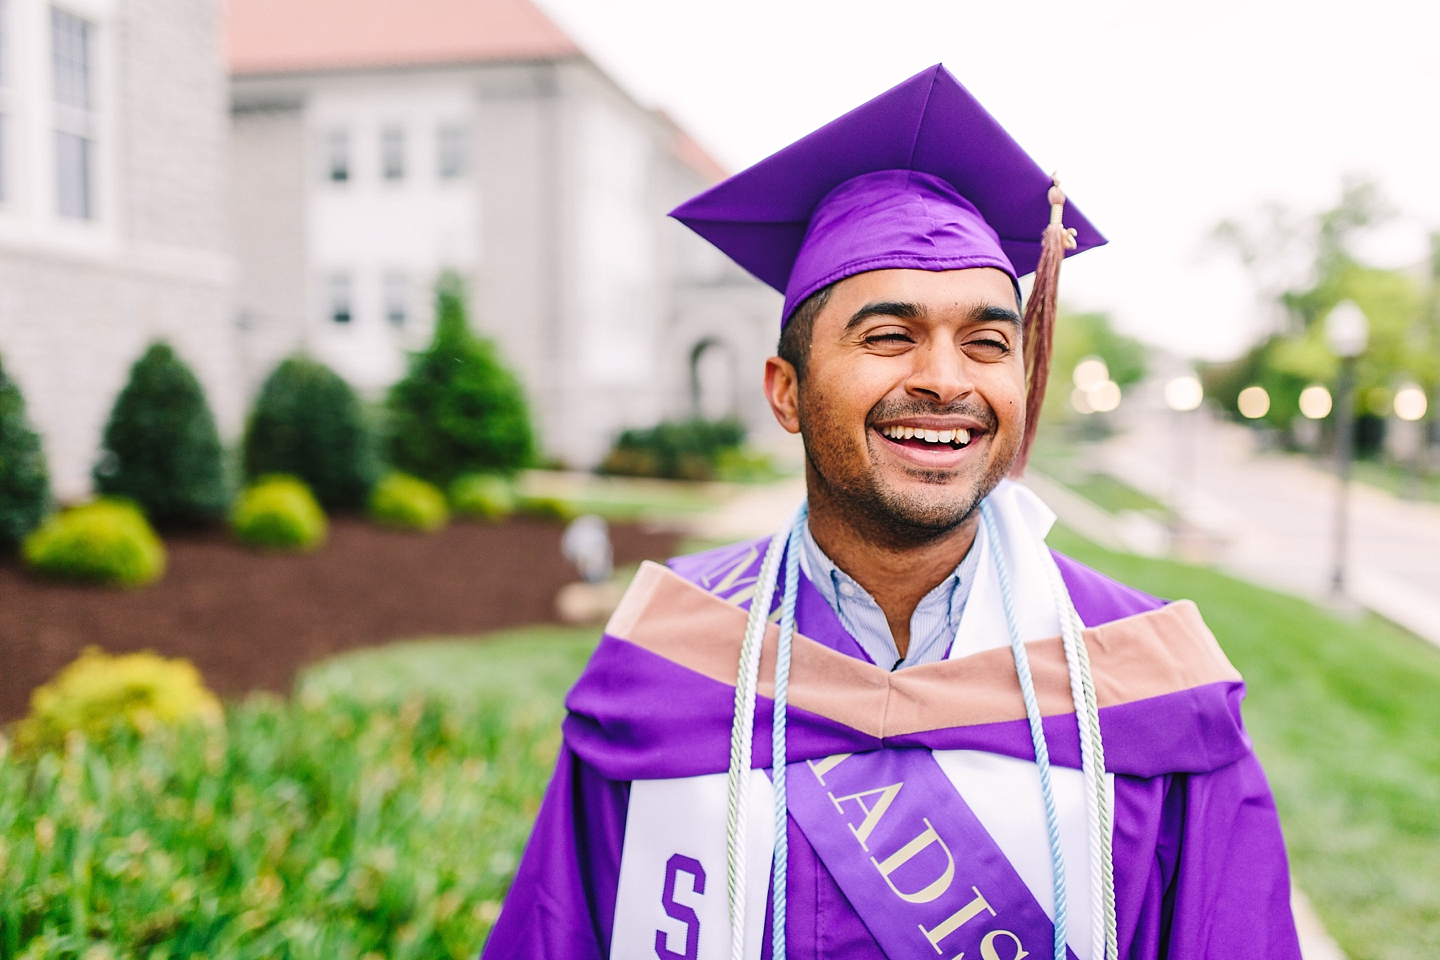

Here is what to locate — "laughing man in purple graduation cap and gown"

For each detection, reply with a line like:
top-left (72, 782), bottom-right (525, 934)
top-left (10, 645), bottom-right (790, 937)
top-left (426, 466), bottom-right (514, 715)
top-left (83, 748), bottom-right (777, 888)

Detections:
top-left (484, 66), bottom-right (1299, 960)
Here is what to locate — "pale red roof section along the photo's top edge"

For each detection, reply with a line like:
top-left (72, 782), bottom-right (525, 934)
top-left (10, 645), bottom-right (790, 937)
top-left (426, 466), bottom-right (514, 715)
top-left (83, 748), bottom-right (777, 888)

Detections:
top-left (226, 0), bottom-right (579, 73)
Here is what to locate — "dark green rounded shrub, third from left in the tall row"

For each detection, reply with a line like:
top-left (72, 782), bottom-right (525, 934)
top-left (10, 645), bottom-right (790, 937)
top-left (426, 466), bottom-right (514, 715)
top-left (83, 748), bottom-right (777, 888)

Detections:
top-left (243, 357), bottom-right (380, 510)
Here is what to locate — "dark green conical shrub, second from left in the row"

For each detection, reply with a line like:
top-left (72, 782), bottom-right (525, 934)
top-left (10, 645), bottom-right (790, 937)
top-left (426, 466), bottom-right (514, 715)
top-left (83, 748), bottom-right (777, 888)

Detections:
top-left (95, 343), bottom-right (229, 527)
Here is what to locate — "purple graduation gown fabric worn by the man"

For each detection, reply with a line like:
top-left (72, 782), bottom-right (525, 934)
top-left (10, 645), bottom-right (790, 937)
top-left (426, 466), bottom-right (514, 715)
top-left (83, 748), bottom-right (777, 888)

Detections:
top-left (481, 540), bottom-right (1300, 960)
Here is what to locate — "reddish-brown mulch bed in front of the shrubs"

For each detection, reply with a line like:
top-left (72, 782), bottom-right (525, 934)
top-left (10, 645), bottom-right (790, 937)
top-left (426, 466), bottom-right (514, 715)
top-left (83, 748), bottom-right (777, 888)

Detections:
top-left (0, 518), bottom-right (677, 720)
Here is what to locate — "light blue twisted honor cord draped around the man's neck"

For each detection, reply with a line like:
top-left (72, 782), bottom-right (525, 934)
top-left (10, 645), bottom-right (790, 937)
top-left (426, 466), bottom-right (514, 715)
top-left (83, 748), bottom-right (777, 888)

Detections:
top-left (770, 502), bottom-right (1067, 960)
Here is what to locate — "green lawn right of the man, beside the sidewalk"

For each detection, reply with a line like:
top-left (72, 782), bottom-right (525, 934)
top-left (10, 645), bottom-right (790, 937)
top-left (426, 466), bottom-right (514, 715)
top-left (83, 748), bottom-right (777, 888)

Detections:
top-left (1050, 530), bottom-right (1440, 960)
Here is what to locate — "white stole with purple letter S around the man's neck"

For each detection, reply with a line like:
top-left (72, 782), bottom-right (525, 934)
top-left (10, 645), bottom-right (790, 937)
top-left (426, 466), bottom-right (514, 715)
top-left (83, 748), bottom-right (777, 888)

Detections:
top-left (611, 481), bottom-right (1115, 960)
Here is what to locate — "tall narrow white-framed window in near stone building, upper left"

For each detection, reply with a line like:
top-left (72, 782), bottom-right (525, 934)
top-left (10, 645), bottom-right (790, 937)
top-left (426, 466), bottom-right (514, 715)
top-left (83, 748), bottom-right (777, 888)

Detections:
top-left (50, 7), bottom-right (95, 220)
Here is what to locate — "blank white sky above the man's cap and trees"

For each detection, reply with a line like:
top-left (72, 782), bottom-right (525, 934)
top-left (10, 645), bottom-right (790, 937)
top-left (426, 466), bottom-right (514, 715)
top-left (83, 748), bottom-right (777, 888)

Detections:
top-left (539, 0), bottom-right (1440, 357)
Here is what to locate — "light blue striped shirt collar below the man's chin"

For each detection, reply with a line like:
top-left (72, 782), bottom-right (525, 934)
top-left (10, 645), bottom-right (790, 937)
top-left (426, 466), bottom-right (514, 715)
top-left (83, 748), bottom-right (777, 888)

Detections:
top-left (801, 524), bottom-right (984, 671)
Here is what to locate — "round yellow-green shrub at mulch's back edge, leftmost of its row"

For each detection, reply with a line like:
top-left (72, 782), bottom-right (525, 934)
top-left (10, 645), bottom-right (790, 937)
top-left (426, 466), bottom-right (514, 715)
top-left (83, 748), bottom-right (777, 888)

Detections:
top-left (23, 499), bottom-right (166, 587)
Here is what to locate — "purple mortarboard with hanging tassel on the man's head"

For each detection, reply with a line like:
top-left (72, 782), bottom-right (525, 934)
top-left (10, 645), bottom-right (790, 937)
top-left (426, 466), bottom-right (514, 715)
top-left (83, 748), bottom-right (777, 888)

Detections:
top-left (671, 63), bottom-right (1106, 469)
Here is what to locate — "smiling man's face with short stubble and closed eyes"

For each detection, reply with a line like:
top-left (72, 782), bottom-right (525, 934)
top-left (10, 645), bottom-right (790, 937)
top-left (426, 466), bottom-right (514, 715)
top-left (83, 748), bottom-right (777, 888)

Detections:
top-left (766, 268), bottom-right (1025, 543)
